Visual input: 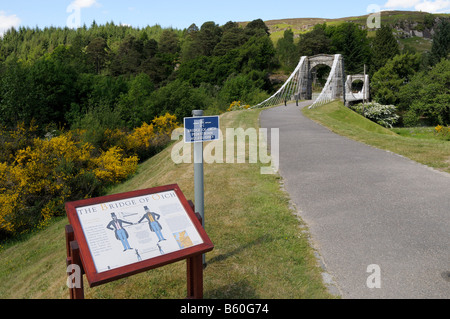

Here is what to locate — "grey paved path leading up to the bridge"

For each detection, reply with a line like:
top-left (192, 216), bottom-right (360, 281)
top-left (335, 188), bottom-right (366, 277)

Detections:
top-left (260, 103), bottom-right (450, 299)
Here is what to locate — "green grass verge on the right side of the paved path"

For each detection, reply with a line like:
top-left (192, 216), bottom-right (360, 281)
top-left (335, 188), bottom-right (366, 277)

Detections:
top-left (303, 101), bottom-right (450, 173)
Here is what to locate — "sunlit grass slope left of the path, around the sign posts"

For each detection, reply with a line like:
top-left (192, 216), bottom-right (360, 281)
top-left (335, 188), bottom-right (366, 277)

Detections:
top-left (0, 110), bottom-right (334, 299)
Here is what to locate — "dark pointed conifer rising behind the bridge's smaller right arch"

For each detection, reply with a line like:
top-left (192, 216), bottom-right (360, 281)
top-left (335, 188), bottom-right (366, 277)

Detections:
top-left (372, 25), bottom-right (400, 72)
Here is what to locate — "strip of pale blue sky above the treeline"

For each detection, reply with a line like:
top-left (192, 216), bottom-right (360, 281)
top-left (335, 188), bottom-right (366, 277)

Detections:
top-left (0, 0), bottom-right (450, 35)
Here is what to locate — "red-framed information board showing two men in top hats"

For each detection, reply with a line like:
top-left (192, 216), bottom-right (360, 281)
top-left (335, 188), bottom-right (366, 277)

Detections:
top-left (66, 185), bottom-right (214, 287)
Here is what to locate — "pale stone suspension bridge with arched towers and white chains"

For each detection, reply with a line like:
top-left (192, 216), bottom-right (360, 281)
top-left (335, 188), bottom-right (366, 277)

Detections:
top-left (254, 54), bottom-right (370, 108)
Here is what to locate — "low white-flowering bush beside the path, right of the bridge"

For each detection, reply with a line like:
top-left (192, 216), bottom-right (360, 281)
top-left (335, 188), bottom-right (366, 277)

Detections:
top-left (350, 102), bottom-right (400, 128)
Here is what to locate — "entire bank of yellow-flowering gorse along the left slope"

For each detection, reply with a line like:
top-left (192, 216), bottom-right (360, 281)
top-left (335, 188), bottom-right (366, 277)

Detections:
top-left (0, 114), bottom-right (178, 239)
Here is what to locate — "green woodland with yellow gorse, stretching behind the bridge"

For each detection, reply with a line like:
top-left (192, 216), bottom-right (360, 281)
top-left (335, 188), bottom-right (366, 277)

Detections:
top-left (0, 18), bottom-right (450, 240)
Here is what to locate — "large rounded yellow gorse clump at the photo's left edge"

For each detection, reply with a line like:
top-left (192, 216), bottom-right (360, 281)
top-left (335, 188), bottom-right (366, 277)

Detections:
top-left (0, 132), bottom-right (99, 238)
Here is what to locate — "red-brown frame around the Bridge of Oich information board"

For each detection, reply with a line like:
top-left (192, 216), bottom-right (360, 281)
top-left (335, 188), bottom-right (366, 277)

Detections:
top-left (66, 184), bottom-right (214, 287)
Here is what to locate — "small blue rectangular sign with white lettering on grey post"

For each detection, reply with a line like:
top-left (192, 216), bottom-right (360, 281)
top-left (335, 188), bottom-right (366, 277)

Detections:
top-left (184, 116), bottom-right (220, 143)
